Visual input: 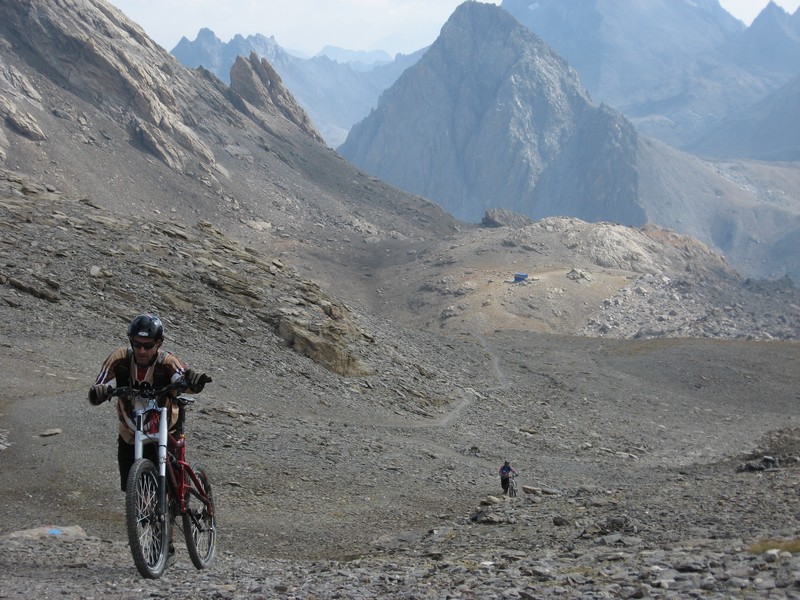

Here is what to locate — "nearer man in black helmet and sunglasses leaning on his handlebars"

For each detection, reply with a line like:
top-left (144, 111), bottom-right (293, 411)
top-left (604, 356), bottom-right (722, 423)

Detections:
top-left (89, 314), bottom-right (211, 492)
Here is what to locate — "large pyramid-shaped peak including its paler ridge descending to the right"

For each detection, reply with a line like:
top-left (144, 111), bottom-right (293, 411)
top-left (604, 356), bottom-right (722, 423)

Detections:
top-left (339, 2), bottom-right (798, 277)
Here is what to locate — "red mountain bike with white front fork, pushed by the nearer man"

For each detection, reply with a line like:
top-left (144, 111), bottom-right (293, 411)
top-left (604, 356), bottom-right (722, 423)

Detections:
top-left (110, 379), bottom-right (217, 579)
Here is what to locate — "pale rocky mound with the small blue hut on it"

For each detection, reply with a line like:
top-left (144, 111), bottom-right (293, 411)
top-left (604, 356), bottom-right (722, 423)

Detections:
top-left (374, 217), bottom-right (800, 340)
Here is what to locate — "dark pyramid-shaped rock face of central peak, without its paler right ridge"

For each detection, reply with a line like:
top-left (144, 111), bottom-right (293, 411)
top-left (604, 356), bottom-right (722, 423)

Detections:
top-left (339, 2), bottom-right (645, 225)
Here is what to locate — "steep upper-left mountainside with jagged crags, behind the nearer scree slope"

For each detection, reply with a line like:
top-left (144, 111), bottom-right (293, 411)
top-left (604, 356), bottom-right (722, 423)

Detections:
top-left (0, 0), bottom-right (454, 254)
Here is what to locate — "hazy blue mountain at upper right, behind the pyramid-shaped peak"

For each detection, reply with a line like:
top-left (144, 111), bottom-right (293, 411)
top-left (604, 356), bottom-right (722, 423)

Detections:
top-left (502, 0), bottom-right (800, 154)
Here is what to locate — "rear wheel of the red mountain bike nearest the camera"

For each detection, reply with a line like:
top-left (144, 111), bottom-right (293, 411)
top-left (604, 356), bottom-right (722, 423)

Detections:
top-left (182, 465), bottom-right (217, 569)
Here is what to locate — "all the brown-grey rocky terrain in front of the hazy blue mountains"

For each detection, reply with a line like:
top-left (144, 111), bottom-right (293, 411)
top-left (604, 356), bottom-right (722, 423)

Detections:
top-left (0, 0), bottom-right (800, 599)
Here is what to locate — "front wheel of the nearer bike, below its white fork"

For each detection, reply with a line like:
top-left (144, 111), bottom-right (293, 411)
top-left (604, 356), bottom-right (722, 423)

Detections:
top-left (125, 458), bottom-right (170, 579)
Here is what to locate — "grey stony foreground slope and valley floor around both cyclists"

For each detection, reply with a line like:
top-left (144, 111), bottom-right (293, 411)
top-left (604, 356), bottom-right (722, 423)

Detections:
top-left (0, 173), bottom-right (800, 598)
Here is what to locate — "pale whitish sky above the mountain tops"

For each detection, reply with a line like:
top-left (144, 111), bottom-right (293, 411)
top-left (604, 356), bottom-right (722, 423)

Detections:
top-left (109, 0), bottom-right (800, 56)
